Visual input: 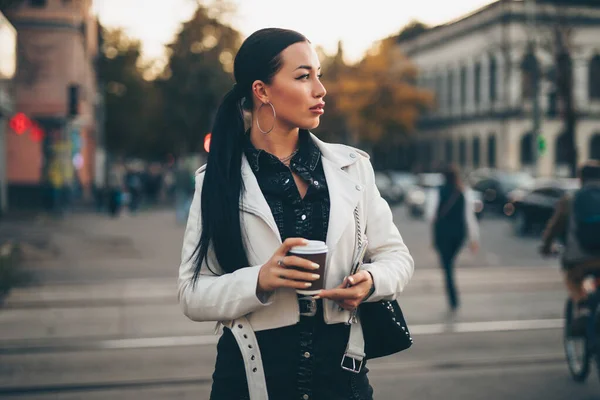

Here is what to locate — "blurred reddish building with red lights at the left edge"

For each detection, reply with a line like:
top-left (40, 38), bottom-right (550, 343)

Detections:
top-left (7, 0), bottom-right (99, 208)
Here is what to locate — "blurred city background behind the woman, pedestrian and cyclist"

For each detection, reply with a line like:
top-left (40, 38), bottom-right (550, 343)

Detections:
top-left (0, 0), bottom-right (600, 400)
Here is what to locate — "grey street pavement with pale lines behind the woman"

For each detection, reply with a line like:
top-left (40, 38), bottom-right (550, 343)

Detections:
top-left (0, 207), bottom-right (600, 400)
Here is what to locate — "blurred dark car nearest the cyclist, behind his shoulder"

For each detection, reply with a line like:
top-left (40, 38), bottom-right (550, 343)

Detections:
top-left (504, 179), bottom-right (580, 235)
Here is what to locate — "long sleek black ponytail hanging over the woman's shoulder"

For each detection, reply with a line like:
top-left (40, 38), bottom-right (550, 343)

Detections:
top-left (192, 85), bottom-right (248, 282)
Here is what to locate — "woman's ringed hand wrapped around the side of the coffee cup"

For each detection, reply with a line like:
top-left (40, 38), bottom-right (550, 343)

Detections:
top-left (256, 238), bottom-right (319, 293)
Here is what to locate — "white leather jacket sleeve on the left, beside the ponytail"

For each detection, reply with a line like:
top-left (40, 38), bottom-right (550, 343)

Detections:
top-left (178, 175), bottom-right (270, 321)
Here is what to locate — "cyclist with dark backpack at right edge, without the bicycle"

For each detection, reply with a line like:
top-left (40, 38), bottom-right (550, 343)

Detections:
top-left (541, 160), bottom-right (600, 336)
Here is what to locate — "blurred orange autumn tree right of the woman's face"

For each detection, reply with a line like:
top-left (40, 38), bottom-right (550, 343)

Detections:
top-left (324, 37), bottom-right (433, 145)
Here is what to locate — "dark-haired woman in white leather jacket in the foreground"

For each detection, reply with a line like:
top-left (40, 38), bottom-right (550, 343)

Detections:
top-left (179, 29), bottom-right (413, 400)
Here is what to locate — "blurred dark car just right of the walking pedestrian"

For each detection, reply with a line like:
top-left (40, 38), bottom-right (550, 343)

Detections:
top-left (470, 171), bottom-right (534, 214)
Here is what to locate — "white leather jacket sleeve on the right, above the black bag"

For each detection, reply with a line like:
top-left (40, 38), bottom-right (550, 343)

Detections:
top-left (362, 160), bottom-right (414, 302)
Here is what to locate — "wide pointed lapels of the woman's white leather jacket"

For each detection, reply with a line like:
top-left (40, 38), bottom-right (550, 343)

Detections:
top-left (240, 133), bottom-right (365, 251)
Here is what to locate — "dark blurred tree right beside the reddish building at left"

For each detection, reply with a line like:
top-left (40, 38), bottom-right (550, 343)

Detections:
top-left (98, 29), bottom-right (162, 158)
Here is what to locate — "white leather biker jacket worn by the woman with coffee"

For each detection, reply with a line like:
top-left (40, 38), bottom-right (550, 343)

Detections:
top-left (179, 134), bottom-right (414, 331)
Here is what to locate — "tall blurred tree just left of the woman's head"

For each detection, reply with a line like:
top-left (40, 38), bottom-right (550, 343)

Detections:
top-left (158, 5), bottom-right (241, 155)
